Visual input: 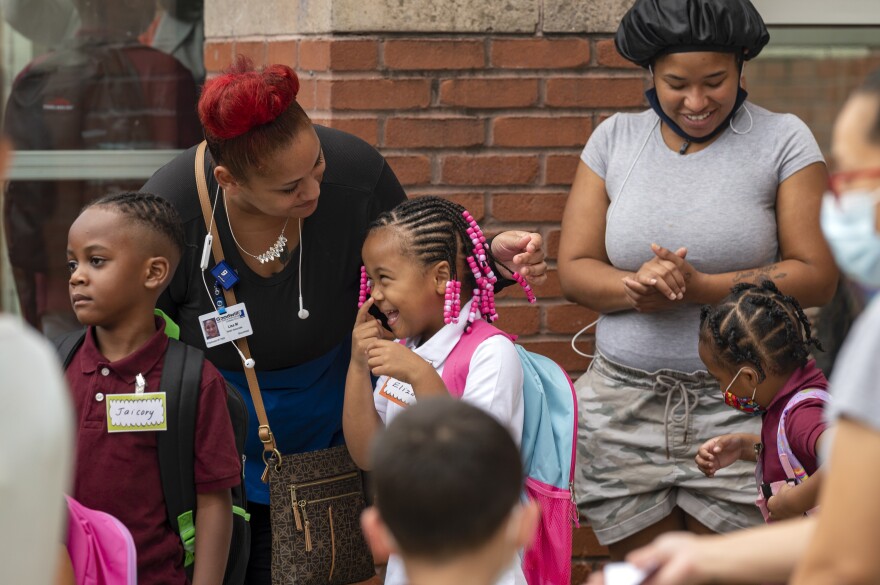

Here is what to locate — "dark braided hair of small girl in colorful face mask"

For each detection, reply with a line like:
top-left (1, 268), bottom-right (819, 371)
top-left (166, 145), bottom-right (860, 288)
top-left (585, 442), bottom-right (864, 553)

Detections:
top-left (700, 280), bottom-right (822, 380)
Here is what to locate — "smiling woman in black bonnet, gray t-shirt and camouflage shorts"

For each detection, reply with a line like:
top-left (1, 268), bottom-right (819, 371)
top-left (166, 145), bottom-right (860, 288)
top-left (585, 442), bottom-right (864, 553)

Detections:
top-left (559, 0), bottom-right (837, 559)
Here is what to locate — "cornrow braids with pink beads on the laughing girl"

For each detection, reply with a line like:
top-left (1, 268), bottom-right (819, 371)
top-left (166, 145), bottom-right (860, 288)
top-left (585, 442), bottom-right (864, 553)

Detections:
top-left (358, 196), bottom-right (534, 330)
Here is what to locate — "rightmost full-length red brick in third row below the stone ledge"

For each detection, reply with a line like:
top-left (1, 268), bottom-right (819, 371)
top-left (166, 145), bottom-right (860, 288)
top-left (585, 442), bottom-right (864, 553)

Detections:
top-left (492, 116), bottom-right (593, 147)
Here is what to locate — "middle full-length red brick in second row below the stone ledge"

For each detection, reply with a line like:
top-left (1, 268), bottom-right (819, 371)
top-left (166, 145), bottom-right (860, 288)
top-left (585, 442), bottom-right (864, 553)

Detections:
top-left (440, 78), bottom-right (538, 108)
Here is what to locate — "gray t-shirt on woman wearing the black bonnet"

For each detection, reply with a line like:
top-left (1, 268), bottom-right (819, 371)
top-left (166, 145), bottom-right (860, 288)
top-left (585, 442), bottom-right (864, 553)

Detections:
top-left (581, 102), bottom-right (823, 372)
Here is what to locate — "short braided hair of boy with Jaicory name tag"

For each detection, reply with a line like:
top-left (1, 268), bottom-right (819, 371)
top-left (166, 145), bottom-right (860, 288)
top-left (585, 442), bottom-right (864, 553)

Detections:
top-left (80, 191), bottom-right (186, 259)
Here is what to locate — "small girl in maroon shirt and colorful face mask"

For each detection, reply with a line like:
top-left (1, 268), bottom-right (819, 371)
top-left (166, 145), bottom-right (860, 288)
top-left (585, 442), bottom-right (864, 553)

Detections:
top-left (696, 280), bottom-right (829, 521)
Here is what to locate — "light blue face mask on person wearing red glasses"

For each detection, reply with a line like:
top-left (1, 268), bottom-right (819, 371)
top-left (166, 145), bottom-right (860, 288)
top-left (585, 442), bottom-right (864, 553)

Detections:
top-left (821, 192), bottom-right (880, 290)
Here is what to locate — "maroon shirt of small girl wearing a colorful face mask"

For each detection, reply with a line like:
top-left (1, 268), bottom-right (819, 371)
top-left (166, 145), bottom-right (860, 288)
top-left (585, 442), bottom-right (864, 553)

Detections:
top-left (761, 360), bottom-right (828, 483)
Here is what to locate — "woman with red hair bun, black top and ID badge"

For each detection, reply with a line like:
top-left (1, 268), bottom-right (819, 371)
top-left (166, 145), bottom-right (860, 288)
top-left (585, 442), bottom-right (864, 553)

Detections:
top-left (143, 57), bottom-right (546, 584)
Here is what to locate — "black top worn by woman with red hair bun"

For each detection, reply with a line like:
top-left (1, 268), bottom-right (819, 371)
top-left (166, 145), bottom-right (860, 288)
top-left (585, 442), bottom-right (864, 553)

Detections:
top-left (142, 126), bottom-right (406, 370)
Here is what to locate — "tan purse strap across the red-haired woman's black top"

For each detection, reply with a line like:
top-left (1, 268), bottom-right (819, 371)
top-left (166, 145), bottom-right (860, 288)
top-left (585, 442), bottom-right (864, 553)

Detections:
top-left (195, 140), bottom-right (281, 474)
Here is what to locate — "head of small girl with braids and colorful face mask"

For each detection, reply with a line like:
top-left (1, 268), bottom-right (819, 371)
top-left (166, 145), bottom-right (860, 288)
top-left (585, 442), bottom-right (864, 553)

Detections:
top-left (699, 280), bottom-right (822, 414)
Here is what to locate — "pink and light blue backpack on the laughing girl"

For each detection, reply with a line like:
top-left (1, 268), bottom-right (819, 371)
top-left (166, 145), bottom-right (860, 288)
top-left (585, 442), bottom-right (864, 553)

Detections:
top-left (441, 320), bottom-right (578, 585)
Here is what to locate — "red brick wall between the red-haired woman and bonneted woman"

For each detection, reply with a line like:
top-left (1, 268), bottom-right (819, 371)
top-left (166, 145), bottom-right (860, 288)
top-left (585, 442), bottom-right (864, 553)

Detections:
top-left (206, 34), bottom-right (645, 583)
